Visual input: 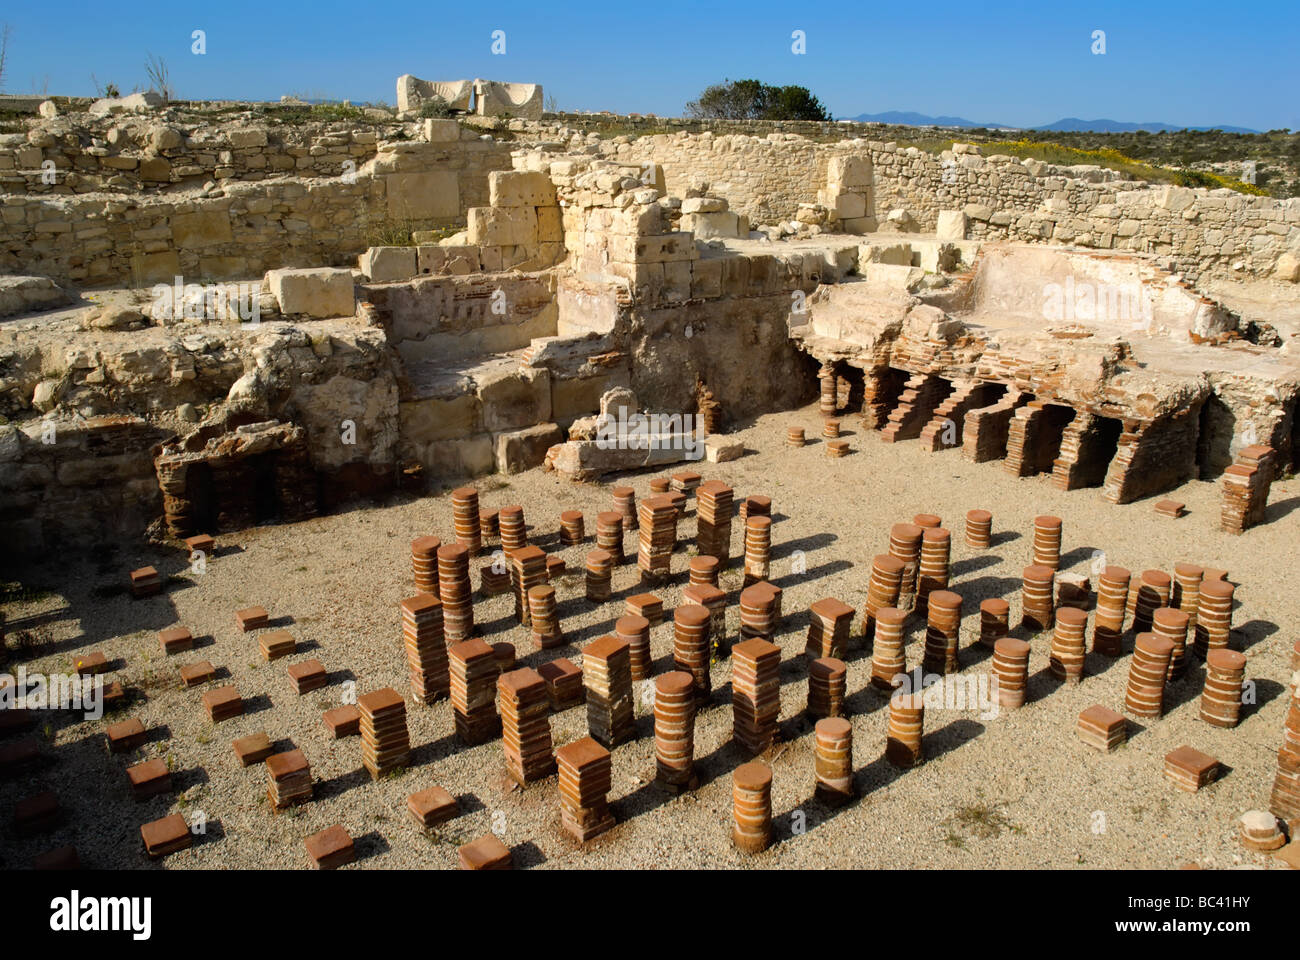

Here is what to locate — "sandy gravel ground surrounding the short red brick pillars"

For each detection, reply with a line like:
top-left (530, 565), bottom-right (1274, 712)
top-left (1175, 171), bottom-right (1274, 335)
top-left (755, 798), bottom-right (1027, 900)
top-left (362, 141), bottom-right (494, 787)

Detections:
top-left (0, 406), bottom-right (1300, 869)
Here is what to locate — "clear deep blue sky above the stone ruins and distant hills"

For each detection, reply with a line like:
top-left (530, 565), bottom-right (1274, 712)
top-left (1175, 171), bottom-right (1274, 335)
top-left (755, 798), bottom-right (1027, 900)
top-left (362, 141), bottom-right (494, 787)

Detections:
top-left (0, 0), bottom-right (1300, 130)
